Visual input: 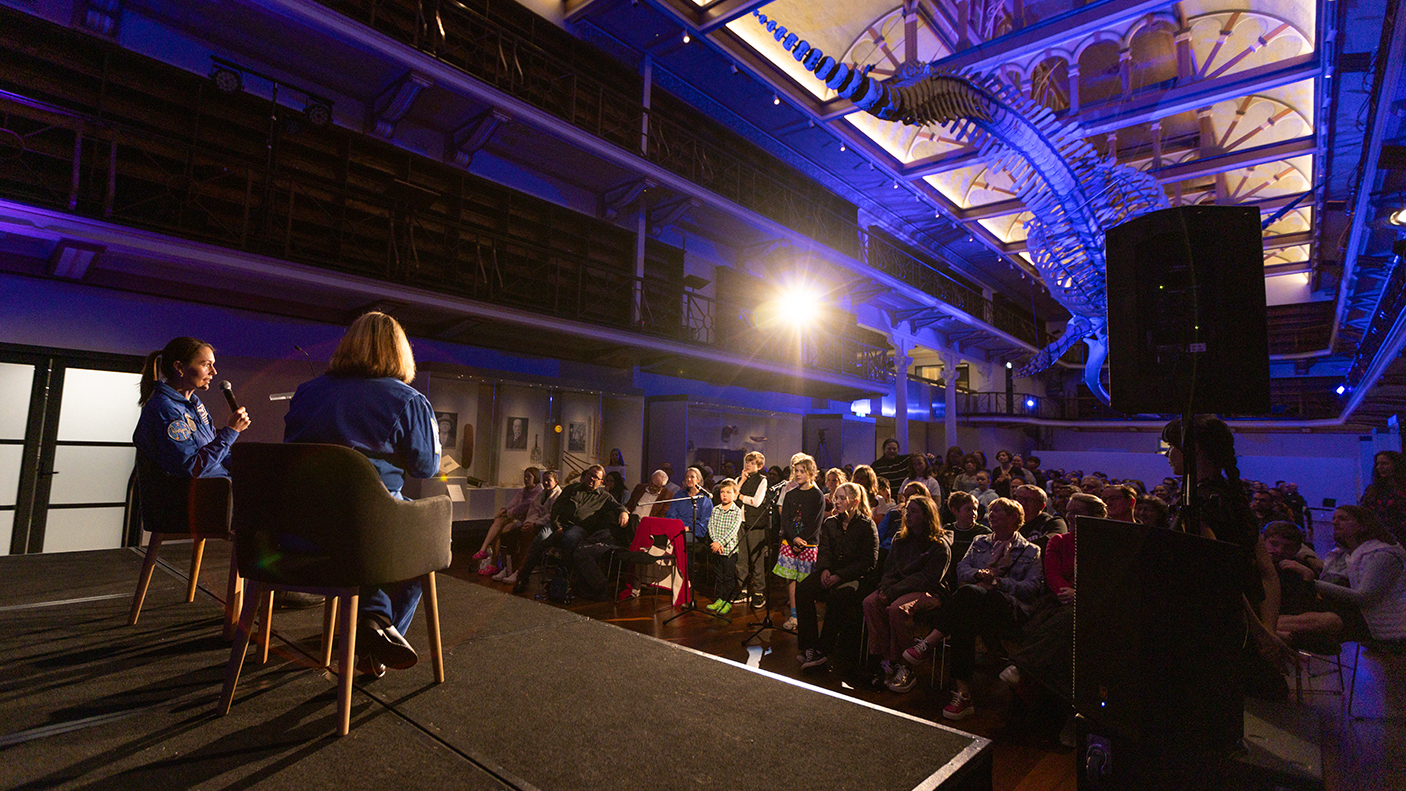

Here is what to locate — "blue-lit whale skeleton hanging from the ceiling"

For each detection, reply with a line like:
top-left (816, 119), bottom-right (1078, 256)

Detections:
top-left (752, 11), bottom-right (1167, 403)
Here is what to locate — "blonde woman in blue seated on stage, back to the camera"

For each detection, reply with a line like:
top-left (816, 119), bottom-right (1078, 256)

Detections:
top-left (283, 312), bottom-right (440, 674)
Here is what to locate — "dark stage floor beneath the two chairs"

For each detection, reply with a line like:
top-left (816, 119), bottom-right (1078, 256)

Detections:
top-left (0, 545), bottom-right (991, 790)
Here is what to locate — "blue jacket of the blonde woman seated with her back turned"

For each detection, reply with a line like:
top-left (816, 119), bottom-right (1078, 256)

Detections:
top-left (283, 374), bottom-right (439, 497)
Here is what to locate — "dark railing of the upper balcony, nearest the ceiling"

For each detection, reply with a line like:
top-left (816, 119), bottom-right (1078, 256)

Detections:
top-left (319, 0), bottom-right (1049, 346)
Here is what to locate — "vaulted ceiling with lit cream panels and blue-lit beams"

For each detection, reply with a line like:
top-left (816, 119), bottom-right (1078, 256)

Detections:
top-left (567, 0), bottom-right (1406, 421)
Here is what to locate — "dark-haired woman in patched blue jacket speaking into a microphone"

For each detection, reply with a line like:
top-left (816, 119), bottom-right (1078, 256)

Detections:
top-left (132, 337), bottom-right (249, 478)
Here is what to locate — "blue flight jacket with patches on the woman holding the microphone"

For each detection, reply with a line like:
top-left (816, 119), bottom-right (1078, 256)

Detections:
top-left (132, 382), bottom-right (239, 478)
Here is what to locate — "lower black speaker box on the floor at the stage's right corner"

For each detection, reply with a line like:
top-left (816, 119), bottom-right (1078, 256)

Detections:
top-left (1074, 517), bottom-right (1246, 770)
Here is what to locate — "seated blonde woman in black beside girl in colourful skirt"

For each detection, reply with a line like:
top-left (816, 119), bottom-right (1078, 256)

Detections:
top-left (796, 483), bottom-right (879, 669)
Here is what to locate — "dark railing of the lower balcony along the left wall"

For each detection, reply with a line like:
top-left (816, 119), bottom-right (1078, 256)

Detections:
top-left (0, 30), bottom-right (889, 384)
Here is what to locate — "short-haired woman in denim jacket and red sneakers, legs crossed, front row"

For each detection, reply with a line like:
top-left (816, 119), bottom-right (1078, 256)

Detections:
top-left (903, 497), bottom-right (1045, 719)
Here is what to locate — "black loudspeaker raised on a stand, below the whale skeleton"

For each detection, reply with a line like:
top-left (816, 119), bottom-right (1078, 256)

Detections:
top-left (1105, 207), bottom-right (1270, 414)
